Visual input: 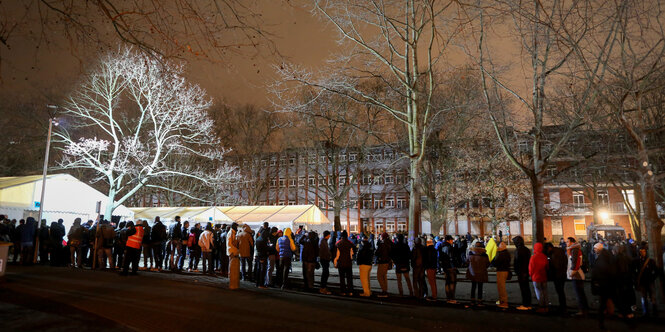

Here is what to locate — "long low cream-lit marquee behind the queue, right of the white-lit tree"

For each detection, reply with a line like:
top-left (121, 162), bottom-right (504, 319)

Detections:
top-left (130, 205), bottom-right (333, 233)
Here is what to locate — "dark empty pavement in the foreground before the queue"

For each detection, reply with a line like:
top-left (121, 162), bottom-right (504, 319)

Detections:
top-left (0, 263), bottom-right (665, 332)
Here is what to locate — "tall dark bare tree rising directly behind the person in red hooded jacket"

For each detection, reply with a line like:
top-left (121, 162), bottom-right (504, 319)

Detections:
top-left (469, 0), bottom-right (627, 241)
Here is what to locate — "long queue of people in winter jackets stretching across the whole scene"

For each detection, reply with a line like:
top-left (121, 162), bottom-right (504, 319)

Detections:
top-left (0, 215), bottom-right (663, 324)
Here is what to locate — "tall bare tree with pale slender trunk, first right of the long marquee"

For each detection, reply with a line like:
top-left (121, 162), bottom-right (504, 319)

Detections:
top-left (280, 0), bottom-right (464, 243)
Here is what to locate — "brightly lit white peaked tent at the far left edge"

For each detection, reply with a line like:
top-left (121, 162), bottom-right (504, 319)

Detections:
top-left (0, 174), bottom-right (134, 229)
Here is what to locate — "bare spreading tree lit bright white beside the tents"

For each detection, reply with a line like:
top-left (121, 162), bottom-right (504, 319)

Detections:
top-left (55, 49), bottom-right (238, 216)
